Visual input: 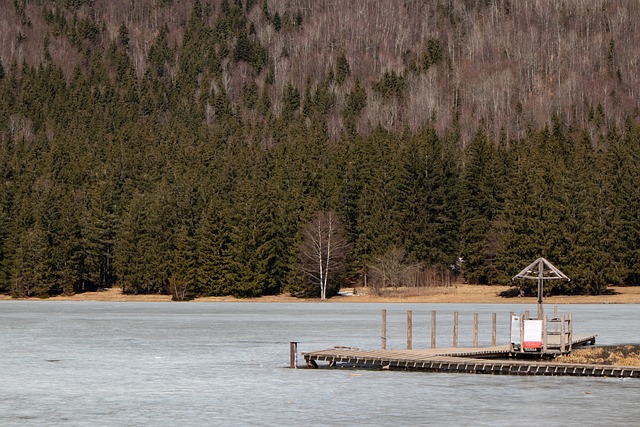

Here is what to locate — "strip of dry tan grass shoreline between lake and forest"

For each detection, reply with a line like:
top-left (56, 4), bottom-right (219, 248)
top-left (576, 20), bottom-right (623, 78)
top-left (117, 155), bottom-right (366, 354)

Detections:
top-left (0, 285), bottom-right (640, 305)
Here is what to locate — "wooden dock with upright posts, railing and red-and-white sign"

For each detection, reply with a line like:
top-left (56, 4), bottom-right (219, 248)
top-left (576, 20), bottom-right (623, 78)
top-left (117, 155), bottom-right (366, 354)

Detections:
top-left (298, 308), bottom-right (640, 378)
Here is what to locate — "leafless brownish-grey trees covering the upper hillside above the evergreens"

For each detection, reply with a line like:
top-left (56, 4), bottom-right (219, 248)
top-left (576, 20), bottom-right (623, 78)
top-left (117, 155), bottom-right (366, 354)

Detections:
top-left (0, 0), bottom-right (640, 144)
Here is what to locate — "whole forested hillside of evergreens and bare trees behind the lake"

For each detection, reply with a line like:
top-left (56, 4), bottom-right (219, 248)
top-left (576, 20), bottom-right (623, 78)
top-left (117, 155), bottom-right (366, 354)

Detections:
top-left (0, 0), bottom-right (640, 299)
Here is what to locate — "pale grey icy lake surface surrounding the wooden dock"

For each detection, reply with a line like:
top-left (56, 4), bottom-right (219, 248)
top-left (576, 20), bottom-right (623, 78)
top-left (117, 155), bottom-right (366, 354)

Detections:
top-left (0, 301), bottom-right (640, 426)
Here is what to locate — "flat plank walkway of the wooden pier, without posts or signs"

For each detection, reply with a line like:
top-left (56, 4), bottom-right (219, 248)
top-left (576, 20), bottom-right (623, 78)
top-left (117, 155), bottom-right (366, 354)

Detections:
top-left (302, 336), bottom-right (640, 378)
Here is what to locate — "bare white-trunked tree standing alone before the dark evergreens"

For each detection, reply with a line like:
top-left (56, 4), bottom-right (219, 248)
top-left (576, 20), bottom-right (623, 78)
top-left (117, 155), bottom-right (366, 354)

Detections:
top-left (300, 210), bottom-right (349, 300)
